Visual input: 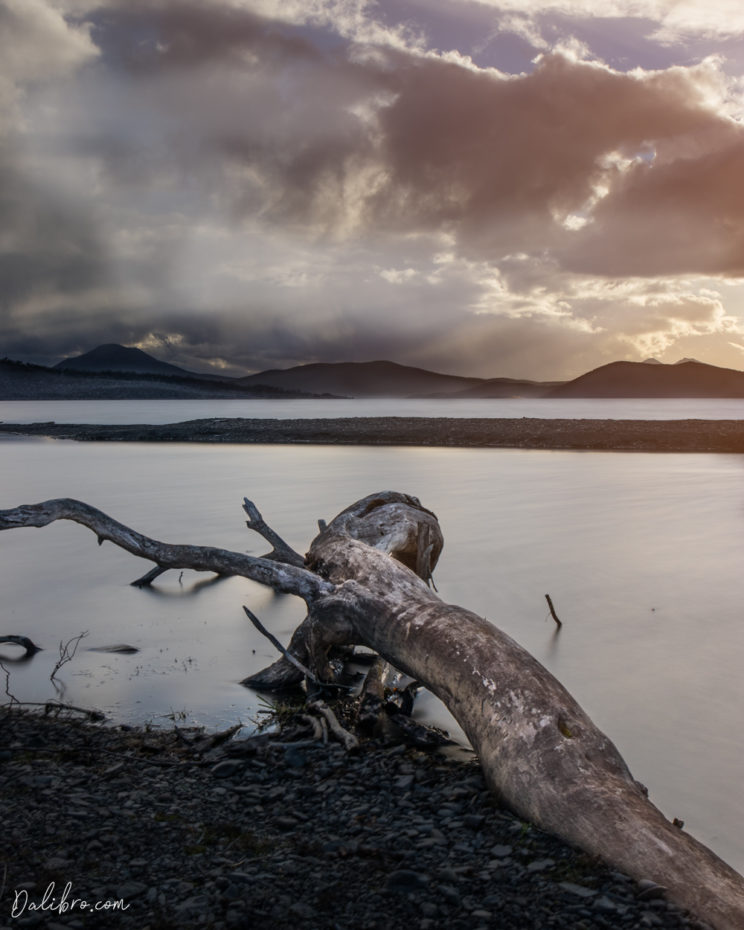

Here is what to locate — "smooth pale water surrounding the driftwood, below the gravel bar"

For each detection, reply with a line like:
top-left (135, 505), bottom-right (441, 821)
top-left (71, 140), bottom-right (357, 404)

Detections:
top-left (0, 440), bottom-right (744, 869)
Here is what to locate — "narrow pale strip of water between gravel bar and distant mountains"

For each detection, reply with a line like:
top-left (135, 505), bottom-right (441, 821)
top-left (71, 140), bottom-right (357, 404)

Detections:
top-left (0, 397), bottom-right (744, 424)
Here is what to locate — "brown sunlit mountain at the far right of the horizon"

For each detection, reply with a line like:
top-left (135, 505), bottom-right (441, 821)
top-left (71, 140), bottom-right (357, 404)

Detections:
top-left (546, 359), bottom-right (744, 397)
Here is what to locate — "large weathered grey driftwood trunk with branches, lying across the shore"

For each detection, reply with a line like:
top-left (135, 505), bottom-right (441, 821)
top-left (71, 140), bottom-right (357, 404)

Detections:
top-left (0, 492), bottom-right (744, 930)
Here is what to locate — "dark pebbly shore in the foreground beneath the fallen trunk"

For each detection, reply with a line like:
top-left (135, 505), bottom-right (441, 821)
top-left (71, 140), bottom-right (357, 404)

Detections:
top-left (0, 706), bottom-right (706, 930)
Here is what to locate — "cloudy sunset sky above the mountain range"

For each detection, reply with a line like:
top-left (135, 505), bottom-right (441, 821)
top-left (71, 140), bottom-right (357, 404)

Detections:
top-left (0, 0), bottom-right (744, 380)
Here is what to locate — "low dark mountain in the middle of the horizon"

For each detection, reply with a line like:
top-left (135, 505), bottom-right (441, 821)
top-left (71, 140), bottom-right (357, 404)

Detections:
top-left (238, 361), bottom-right (484, 397)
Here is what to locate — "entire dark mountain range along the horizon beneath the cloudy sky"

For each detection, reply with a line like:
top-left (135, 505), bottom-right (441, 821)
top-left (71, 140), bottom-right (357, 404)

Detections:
top-left (0, 343), bottom-right (744, 400)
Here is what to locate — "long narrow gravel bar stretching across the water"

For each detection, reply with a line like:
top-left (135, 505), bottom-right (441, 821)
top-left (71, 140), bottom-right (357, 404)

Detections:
top-left (0, 417), bottom-right (744, 454)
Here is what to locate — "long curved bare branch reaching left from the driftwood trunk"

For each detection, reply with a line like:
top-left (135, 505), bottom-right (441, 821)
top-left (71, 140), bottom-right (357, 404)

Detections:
top-left (0, 498), bottom-right (333, 603)
